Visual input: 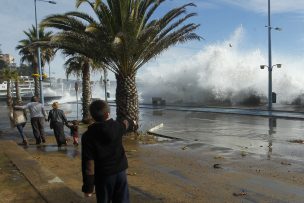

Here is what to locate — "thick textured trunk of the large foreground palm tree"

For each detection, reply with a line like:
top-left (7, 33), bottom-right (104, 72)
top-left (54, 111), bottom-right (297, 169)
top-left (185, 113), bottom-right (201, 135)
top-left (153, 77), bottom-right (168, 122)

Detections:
top-left (116, 75), bottom-right (139, 122)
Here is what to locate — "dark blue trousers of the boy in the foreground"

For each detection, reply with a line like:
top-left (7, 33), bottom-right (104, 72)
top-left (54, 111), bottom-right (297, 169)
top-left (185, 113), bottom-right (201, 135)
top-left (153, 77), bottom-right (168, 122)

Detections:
top-left (95, 170), bottom-right (130, 203)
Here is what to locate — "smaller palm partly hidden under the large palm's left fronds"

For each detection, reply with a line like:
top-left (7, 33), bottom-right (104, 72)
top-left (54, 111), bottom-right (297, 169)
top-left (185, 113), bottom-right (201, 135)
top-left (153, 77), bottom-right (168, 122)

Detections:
top-left (64, 54), bottom-right (92, 123)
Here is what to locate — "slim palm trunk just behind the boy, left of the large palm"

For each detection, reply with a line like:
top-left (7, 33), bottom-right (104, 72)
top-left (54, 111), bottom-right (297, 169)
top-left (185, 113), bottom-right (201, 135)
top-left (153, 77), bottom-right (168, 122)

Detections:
top-left (82, 63), bottom-right (92, 123)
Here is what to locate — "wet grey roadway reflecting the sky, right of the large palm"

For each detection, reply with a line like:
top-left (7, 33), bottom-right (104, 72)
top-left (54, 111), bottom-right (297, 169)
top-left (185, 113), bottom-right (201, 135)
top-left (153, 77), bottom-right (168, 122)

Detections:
top-left (142, 110), bottom-right (304, 161)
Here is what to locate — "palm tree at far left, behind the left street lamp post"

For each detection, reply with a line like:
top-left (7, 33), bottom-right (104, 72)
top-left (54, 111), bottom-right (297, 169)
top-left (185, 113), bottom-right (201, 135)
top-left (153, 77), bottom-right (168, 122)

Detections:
top-left (16, 25), bottom-right (55, 96)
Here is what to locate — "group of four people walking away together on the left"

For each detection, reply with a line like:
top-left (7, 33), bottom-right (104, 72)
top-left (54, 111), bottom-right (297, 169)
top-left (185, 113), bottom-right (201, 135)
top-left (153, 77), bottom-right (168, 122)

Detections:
top-left (9, 96), bottom-right (79, 147)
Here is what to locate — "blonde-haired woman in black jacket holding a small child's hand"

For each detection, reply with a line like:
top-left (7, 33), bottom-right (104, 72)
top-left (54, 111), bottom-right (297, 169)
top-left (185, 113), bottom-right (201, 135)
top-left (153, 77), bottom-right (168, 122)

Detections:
top-left (48, 102), bottom-right (67, 147)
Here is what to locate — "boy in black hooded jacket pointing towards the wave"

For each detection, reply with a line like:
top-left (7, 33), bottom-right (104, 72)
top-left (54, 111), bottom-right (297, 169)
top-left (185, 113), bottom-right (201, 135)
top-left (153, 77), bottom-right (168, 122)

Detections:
top-left (81, 100), bottom-right (137, 203)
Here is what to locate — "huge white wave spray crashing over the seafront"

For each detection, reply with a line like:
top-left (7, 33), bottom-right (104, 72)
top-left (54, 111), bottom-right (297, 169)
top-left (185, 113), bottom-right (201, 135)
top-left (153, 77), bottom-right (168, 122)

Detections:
top-left (139, 27), bottom-right (304, 104)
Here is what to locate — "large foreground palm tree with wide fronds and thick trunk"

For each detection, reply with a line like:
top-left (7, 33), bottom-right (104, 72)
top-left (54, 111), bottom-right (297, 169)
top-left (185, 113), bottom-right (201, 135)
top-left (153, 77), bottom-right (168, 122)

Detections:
top-left (42, 0), bottom-right (201, 121)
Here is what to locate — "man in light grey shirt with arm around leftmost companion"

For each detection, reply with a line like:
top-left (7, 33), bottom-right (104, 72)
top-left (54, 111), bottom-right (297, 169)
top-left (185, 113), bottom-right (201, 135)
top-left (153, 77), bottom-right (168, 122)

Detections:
top-left (14, 96), bottom-right (46, 144)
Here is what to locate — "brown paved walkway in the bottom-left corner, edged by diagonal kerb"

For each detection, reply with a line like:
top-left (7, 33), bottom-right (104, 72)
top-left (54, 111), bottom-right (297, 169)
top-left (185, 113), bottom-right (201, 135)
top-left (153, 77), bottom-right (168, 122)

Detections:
top-left (0, 140), bottom-right (162, 203)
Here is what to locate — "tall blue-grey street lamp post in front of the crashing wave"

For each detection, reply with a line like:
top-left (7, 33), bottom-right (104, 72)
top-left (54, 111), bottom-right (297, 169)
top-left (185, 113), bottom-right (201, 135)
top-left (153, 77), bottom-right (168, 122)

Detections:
top-left (261, 0), bottom-right (282, 111)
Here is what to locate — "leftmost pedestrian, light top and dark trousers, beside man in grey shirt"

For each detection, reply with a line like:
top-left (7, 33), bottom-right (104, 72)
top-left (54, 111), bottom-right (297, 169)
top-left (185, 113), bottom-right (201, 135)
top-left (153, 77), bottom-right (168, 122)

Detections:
top-left (9, 102), bottom-right (28, 146)
